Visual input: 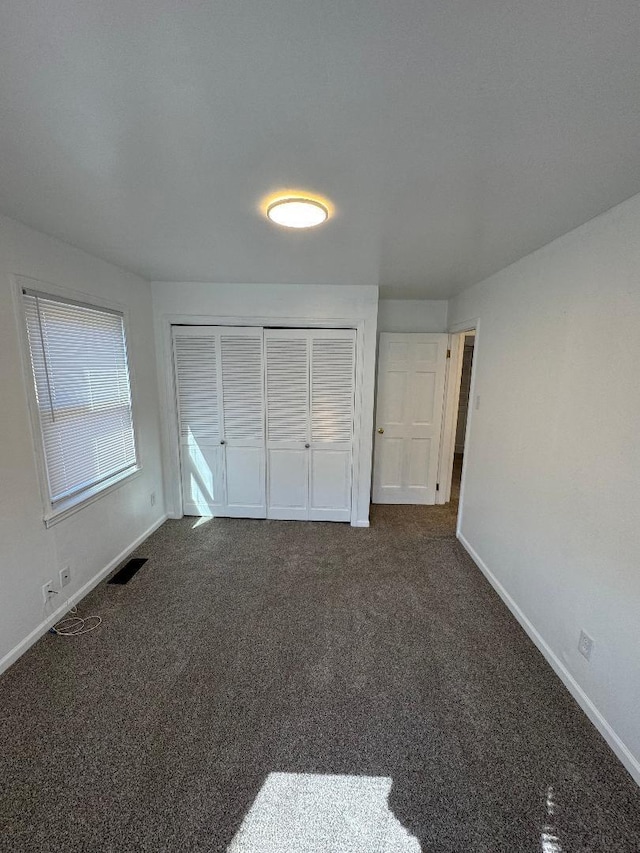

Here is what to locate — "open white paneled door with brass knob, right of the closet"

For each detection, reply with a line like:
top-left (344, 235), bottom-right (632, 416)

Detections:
top-left (373, 333), bottom-right (448, 504)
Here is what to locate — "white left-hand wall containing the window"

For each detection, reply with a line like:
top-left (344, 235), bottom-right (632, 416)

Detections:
top-left (0, 213), bottom-right (164, 671)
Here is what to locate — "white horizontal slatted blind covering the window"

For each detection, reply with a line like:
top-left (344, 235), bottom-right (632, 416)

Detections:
top-left (23, 290), bottom-right (137, 510)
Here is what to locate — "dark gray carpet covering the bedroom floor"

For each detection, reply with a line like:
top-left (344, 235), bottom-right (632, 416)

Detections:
top-left (0, 507), bottom-right (640, 853)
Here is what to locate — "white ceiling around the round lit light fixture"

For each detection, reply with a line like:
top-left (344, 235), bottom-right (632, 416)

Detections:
top-left (0, 0), bottom-right (640, 298)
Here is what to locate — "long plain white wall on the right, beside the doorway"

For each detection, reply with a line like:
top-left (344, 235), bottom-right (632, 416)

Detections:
top-left (449, 196), bottom-right (640, 782)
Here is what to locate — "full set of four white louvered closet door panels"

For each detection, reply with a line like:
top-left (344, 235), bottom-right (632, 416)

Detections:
top-left (173, 326), bottom-right (356, 521)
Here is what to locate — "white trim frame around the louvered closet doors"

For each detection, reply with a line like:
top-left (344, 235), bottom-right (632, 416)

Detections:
top-left (157, 314), bottom-right (364, 527)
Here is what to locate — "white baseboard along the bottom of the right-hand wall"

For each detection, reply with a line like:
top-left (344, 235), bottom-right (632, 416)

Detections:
top-left (457, 531), bottom-right (640, 785)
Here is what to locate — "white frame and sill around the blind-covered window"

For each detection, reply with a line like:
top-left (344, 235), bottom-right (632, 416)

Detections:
top-left (12, 274), bottom-right (143, 527)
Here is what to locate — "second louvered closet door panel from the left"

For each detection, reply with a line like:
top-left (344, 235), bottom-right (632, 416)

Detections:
top-left (218, 327), bottom-right (267, 518)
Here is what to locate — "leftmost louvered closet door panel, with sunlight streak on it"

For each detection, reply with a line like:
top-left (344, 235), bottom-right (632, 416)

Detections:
top-left (173, 326), bottom-right (226, 516)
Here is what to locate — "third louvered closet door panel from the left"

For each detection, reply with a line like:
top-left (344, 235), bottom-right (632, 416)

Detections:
top-left (264, 329), bottom-right (310, 520)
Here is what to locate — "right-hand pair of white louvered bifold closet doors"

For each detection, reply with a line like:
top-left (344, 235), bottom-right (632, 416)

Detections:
top-left (265, 329), bottom-right (356, 521)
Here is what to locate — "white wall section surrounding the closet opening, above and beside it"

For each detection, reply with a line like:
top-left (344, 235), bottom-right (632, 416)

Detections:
top-left (151, 282), bottom-right (378, 526)
